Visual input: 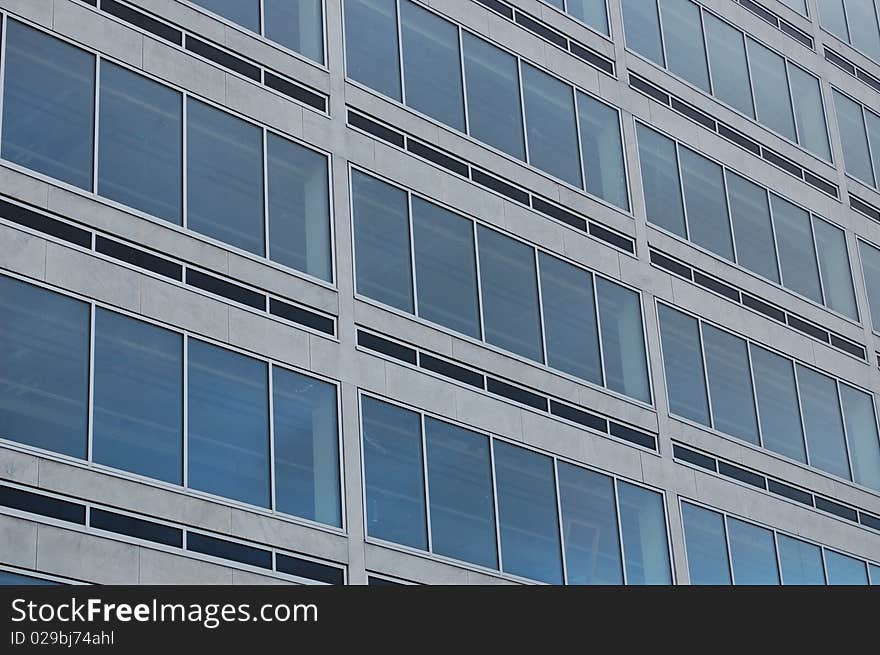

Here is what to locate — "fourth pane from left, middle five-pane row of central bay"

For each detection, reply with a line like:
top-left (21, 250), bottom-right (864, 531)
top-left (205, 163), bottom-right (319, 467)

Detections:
top-left (539, 253), bottom-right (602, 384)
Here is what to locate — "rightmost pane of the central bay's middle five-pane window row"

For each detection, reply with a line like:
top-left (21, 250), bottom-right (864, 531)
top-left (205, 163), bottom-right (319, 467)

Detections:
top-left (596, 278), bottom-right (651, 403)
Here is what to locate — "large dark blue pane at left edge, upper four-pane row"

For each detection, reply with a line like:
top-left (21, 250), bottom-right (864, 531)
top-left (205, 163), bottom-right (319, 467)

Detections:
top-left (2, 20), bottom-right (95, 191)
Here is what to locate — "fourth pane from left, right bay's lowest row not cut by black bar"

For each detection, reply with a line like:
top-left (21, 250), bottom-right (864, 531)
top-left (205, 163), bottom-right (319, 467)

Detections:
top-left (797, 364), bottom-right (852, 480)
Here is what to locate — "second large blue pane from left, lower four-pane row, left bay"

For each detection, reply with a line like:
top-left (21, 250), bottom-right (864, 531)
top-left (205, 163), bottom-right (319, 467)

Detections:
top-left (92, 309), bottom-right (183, 484)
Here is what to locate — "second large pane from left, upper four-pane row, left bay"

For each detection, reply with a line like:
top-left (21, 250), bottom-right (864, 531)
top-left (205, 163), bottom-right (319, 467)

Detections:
top-left (98, 61), bottom-right (183, 225)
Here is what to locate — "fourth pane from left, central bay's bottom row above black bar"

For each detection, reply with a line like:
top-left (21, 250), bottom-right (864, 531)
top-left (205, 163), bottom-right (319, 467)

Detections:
top-left (558, 462), bottom-right (623, 585)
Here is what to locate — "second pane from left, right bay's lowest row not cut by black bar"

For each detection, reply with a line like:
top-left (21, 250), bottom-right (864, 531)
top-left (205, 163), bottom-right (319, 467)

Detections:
top-left (703, 323), bottom-right (759, 445)
